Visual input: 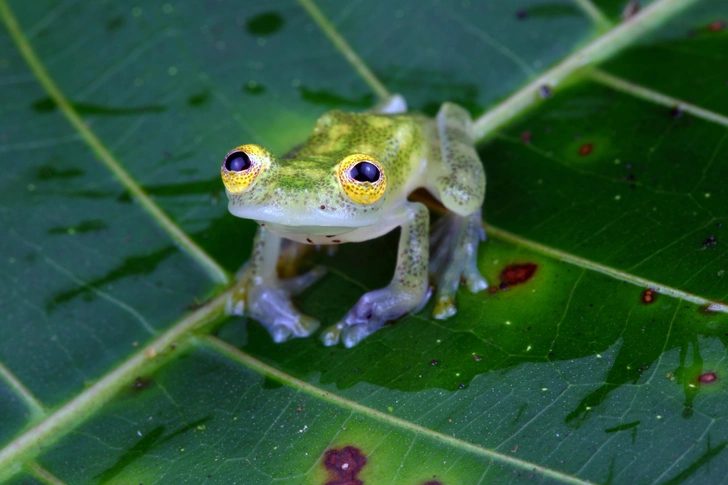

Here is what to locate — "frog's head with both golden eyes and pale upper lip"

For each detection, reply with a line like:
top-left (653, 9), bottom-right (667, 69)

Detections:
top-left (221, 145), bottom-right (387, 235)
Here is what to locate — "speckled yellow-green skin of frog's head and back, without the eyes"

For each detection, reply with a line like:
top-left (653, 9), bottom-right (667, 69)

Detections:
top-left (228, 110), bottom-right (433, 239)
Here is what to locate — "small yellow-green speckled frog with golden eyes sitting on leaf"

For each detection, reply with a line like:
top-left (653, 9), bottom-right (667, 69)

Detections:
top-left (221, 95), bottom-right (488, 348)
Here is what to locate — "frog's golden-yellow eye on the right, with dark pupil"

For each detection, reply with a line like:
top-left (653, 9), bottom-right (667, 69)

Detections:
top-left (337, 153), bottom-right (387, 204)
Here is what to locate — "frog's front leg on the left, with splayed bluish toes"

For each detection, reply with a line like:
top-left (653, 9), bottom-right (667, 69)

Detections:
top-left (227, 227), bottom-right (324, 342)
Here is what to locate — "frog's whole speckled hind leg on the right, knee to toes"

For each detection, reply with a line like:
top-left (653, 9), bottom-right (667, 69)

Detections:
top-left (430, 103), bottom-right (488, 319)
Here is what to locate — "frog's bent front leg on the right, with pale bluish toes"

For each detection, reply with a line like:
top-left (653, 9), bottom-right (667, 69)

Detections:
top-left (321, 202), bottom-right (430, 347)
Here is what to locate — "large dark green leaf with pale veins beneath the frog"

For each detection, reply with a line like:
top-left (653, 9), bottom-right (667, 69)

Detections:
top-left (0, 0), bottom-right (728, 485)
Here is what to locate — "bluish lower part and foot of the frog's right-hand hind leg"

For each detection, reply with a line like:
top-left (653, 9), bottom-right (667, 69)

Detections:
top-left (430, 210), bottom-right (488, 320)
